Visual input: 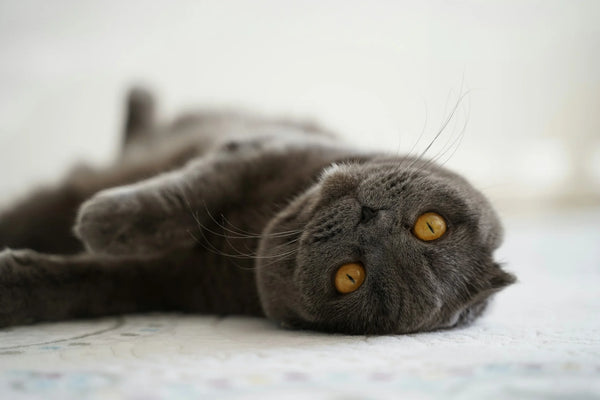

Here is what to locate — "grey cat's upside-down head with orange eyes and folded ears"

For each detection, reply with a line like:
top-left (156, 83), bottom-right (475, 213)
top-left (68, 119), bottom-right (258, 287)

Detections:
top-left (257, 158), bottom-right (514, 334)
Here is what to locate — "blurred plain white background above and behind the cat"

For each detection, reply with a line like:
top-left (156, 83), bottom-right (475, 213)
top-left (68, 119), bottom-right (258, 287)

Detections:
top-left (0, 0), bottom-right (600, 214)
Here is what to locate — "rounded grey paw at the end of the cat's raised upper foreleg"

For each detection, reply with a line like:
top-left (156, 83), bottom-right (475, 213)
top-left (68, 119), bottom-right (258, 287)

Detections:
top-left (74, 193), bottom-right (140, 255)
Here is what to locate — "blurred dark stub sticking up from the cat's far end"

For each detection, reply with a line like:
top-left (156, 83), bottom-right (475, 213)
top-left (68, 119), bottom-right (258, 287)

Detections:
top-left (123, 87), bottom-right (155, 147)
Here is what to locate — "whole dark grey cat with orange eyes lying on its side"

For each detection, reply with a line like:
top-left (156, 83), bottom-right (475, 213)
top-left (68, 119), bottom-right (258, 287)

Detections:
top-left (0, 89), bottom-right (515, 334)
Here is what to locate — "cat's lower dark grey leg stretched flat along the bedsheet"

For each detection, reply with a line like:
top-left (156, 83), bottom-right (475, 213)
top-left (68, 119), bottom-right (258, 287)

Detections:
top-left (0, 249), bottom-right (262, 327)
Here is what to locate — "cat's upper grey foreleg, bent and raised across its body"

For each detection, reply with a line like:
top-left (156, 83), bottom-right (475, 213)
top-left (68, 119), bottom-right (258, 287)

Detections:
top-left (75, 150), bottom-right (249, 255)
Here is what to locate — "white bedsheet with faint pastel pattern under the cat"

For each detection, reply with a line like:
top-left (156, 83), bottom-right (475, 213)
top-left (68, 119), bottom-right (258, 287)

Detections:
top-left (0, 210), bottom-right (600, 400)
